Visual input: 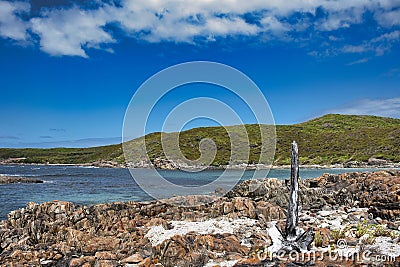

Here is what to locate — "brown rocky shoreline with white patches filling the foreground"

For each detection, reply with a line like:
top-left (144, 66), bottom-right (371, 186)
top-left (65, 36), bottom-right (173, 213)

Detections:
top-left (0, 170), bottom-right (400, 267)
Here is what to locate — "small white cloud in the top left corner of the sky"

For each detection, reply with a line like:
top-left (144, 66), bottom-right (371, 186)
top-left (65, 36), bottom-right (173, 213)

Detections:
top-left (0, 1), bottom-right (30, 41)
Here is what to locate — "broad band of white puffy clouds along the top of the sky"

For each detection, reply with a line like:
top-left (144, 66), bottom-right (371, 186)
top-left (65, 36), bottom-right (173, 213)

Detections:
top-left (0, 0), bottom-right (400, 57)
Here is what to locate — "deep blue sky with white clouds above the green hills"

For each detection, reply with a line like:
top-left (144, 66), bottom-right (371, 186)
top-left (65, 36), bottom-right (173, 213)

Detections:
top-left (0, 0), bottom-right (400, 147)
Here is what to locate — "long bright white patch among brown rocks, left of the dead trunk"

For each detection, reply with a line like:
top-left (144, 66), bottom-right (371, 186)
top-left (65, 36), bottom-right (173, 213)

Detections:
top-left (145, 217), bottom-right (261, 246)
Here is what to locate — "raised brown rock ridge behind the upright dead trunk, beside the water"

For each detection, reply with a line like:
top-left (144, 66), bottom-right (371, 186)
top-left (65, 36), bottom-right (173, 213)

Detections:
top-left (227, 170), bottom-right (400, 220)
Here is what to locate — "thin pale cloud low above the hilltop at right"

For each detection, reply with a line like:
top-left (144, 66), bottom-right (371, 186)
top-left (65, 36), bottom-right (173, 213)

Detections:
top-left (327, 97), bottom-right (400, 118)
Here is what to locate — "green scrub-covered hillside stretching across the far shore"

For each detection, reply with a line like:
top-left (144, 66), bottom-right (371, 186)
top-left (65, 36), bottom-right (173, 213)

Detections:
top-left (0, 114), bottom-right (400, 166)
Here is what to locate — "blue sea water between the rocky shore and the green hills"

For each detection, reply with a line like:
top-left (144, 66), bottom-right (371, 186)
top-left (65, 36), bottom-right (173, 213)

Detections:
top-left (0, 165), bottom-right (394, 220)
